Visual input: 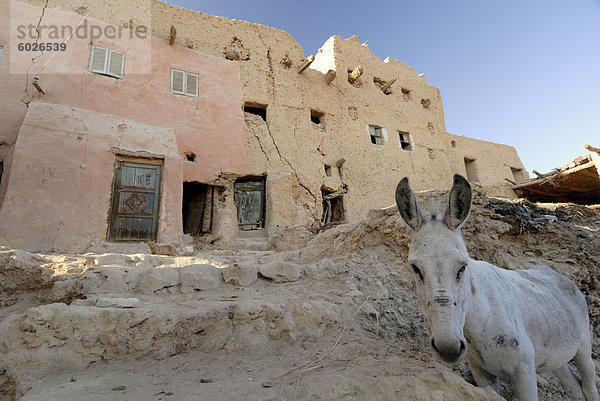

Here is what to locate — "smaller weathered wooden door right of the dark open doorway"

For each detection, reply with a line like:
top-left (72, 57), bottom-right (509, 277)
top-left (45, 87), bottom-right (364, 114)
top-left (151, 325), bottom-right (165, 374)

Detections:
top-left (234, 179), bottom-right (265, 231)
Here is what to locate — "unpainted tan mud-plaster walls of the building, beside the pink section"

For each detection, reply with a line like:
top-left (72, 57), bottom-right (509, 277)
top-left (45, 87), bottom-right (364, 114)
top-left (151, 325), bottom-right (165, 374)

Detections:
top-left (3, 0), bottom-right (526, 241)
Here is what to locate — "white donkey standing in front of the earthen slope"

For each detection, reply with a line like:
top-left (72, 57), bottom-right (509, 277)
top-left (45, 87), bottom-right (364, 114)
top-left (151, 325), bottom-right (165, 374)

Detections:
top-left (396, 175), bottom-right (598, 401)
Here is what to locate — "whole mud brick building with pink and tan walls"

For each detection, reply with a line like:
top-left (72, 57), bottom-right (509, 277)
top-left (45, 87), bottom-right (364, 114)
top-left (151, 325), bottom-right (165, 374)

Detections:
top-left (0, 0), bottom-right (528, 251)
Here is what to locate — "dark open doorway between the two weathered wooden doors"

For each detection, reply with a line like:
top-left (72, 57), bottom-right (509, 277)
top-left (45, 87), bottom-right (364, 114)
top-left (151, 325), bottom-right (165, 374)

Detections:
top-left (181, 182), bottom-right (215, 237)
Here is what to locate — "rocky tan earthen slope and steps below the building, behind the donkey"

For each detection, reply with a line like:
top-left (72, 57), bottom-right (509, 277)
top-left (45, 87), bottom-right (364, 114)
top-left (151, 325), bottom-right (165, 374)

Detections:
top-left (0, 191), bottom-right (600, 401)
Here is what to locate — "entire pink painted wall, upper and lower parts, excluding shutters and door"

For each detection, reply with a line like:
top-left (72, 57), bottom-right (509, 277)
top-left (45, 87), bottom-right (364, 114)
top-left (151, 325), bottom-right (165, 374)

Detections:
top-left (0, 0), bottom-right (248, 251)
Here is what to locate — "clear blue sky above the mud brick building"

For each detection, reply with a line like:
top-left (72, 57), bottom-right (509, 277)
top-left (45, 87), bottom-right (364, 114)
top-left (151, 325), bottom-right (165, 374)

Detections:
top-left (169, 0), bottom-right (600, 172)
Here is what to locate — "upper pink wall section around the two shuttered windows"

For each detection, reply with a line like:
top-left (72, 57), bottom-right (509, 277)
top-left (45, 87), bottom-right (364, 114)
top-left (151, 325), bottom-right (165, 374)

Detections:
top-left (0, 0), bottom-right (248, 188)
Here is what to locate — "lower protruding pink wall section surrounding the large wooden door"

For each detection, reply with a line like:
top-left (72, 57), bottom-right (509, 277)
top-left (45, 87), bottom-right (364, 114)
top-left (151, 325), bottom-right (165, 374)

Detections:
top-left (0, 102), bottom-right (183, 252)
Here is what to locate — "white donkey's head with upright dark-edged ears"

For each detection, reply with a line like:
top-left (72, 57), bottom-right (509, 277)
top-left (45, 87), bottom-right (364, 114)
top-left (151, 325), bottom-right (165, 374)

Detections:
top-left (396, 174), bottom-right (471, 362)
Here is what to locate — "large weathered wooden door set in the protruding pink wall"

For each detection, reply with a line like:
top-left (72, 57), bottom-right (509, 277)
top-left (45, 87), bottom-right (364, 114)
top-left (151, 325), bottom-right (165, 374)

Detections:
top-left (109, 160), bottom-right (161, 241)
